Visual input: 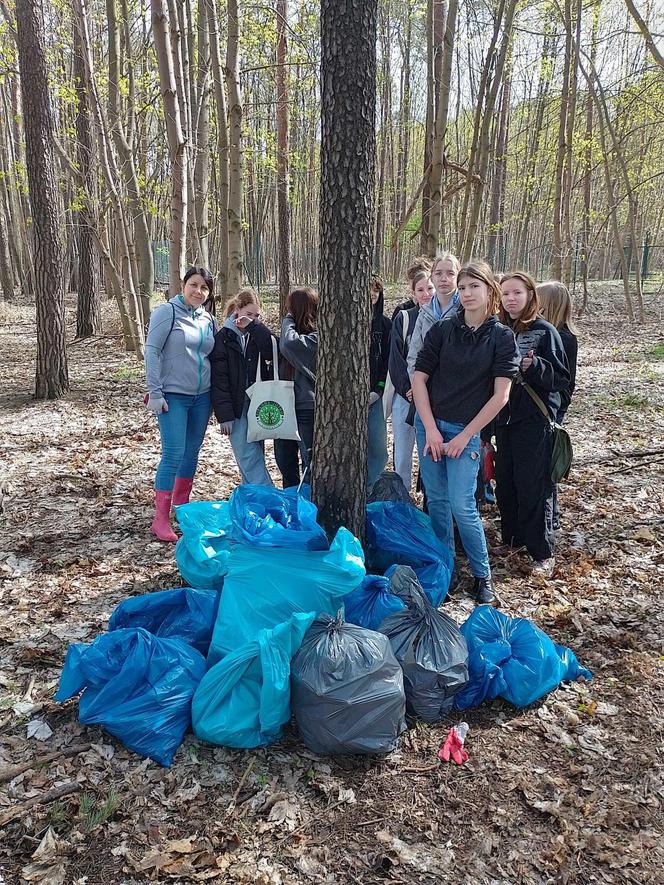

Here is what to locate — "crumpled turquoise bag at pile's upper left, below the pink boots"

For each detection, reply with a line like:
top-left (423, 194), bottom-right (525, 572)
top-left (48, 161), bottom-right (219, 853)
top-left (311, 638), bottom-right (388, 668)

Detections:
top-left (175, 501), bottom-right (234, 590)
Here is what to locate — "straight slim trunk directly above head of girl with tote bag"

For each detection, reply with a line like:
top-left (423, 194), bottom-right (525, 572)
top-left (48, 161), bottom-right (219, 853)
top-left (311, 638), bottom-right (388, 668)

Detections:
top-left (226, 0), bottom-right (244, 296)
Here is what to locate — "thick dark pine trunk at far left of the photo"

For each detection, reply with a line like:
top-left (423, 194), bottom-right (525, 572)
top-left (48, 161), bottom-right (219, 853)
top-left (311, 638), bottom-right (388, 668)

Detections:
top-left (16, 0), bottom-right (69, 399)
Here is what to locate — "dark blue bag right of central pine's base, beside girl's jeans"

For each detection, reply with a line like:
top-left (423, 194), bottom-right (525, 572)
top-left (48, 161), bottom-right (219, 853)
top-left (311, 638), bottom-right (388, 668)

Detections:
top-left (367, 501), bottom-right (454, 607)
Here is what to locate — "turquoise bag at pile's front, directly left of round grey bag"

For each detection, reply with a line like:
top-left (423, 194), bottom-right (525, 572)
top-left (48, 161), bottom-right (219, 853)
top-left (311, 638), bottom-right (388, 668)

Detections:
top-left (192, 612), bottom-right (315, 749)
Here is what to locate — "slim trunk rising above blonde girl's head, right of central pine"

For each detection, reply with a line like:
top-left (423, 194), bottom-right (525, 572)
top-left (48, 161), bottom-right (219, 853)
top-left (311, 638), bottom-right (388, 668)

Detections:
top-left (426, 0), bottom-right (458, 258)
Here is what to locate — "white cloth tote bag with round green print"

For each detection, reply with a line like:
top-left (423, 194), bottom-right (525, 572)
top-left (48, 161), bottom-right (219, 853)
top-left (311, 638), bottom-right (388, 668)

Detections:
top-left (247, 336), bottom-right (300, 442)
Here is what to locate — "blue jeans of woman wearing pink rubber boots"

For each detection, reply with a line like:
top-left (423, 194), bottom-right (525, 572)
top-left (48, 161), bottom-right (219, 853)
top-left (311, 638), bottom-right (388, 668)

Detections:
top-left (154, 391), bottom-right (210, 492)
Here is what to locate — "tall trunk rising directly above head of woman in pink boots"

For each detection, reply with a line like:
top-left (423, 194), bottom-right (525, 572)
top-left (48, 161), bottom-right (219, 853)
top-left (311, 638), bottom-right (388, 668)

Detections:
top-left (151, 0), bottom-right (188, 296)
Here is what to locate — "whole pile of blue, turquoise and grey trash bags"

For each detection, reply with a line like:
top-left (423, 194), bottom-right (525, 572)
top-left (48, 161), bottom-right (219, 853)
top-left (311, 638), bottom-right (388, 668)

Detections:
top-left (56, 485), bottom-right (590, 766)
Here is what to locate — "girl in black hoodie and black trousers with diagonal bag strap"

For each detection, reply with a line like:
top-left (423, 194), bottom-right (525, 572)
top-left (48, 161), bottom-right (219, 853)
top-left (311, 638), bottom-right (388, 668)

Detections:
top-left (496, 271), bottom-right (570, 574)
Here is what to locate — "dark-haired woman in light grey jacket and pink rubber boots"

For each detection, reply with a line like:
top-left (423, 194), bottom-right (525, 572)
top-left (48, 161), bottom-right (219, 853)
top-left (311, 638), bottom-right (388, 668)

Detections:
top-left (145, 267), bottom-right (215, 541)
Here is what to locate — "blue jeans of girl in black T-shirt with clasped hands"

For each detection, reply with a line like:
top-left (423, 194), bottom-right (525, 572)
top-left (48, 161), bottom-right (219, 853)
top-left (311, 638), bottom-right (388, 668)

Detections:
top-left (415, 415), bottom-right (491, 578)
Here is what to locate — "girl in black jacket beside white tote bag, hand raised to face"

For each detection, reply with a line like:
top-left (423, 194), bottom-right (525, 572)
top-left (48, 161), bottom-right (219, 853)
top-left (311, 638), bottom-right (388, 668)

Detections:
top-left (210, 288), bottom-right (276, 486)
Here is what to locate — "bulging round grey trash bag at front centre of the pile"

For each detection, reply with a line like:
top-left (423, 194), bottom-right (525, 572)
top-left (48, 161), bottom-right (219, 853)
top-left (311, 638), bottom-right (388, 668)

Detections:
top-left (291, 614), bottom-right (406, 754)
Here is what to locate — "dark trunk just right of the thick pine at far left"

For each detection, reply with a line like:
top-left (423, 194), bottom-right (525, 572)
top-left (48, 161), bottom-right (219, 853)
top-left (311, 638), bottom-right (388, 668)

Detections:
top-left (74, 26), bottom-right (101, 338)
